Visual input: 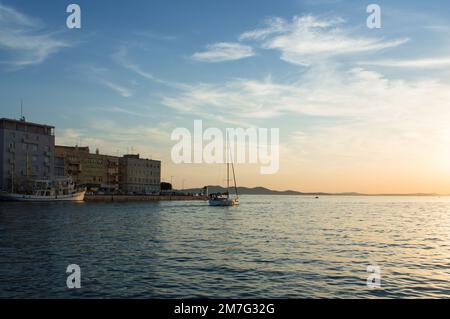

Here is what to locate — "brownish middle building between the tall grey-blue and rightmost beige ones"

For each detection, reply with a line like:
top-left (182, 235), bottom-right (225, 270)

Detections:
top-left (55, 145), bottom-right (119, 192)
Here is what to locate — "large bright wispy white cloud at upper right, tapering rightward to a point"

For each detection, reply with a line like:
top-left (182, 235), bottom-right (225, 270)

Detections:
top-left (239, 15), bottom-right (408, 65)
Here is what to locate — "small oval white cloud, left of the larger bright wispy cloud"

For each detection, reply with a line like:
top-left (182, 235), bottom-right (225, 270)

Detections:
top-left (192, 42), bottom-right (255, 62)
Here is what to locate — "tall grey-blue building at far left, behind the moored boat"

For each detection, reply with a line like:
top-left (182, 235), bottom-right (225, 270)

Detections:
top-left (0, 117), bottom-right (55, 191)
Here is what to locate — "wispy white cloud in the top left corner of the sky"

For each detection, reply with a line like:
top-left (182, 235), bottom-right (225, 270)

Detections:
top-left (0, 3), bottom-right (70, 68)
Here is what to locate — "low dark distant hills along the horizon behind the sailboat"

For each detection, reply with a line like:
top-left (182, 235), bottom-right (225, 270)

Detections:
top-left (180, 185), bottom-right (438, 196)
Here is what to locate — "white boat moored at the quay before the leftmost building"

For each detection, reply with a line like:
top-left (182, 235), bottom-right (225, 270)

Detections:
top-left (0, 177), bottom-right (86, 202)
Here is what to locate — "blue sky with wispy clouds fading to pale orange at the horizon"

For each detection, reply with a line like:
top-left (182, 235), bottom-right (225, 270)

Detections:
top-left (0, 0), bottom-right (450, 194)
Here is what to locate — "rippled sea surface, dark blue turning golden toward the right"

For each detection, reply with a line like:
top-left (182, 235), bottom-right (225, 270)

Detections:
top-left (0, 196), bottom-right (450, 298)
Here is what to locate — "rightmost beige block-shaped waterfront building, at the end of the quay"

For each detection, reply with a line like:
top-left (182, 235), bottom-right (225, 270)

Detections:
top-left (119, 154), bottom-right (161, 194)
